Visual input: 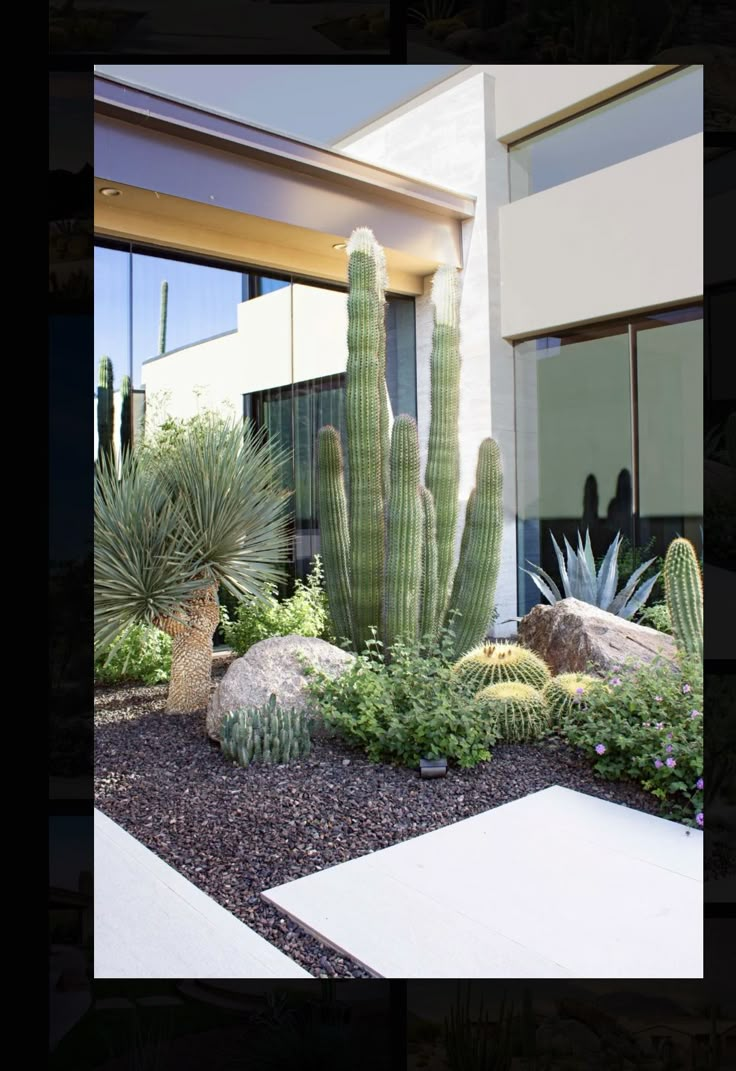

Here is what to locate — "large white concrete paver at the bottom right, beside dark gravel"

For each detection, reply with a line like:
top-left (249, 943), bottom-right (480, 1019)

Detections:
top-left (262, 786), bottom-right (703, 978)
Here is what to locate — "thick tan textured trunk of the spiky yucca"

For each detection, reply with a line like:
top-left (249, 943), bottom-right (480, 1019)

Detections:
top-left (156, 586), bottom-right (220, 714)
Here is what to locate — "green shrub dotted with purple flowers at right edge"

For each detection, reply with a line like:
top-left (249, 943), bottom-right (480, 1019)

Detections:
top-left (561, 655), bottom-right (703, 826)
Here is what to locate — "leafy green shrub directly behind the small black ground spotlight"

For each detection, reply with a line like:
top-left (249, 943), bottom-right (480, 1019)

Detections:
top-left (307, 629), bottom-right (495, 767)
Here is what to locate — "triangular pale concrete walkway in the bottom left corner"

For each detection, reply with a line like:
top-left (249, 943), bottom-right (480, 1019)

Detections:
top-left (94, 810), bottom-right (312, 978)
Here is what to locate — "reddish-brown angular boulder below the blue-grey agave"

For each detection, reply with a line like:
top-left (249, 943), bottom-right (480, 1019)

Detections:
top-left (519, 599), bottom-right (676, 675)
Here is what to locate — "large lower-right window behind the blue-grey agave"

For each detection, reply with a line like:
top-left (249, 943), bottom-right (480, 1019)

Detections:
top-left (514, 306), bottom-right (703, 615)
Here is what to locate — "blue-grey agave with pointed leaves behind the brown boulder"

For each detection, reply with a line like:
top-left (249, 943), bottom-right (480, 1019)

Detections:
top-left (523, 530), bottom-right (659, 620)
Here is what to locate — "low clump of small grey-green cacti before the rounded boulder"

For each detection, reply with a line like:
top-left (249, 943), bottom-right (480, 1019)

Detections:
top-left (220, 695), bottom-right (312, 766)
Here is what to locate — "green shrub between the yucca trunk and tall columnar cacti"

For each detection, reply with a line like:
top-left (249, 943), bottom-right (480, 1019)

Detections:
top-left (220, 555), bottom-right (334, 654)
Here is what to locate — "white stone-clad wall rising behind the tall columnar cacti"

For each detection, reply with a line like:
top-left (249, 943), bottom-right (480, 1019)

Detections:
top-left (334, 67), bottom-right (516, 635)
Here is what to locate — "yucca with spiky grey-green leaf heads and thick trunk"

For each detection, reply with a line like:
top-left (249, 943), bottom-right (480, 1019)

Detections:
top-left (94, 414), bottom-right (288, 712)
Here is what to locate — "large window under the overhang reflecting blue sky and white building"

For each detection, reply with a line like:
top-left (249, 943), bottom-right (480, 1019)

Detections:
top-left (95, 246), bottom-right (417, 576)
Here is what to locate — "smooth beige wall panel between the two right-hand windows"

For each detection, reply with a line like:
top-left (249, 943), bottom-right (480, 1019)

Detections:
top-left (500, 134), bottom-right (703, 337)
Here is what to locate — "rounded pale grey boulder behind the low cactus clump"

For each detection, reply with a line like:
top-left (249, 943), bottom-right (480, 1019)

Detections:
top-left (207, 636), bottom-right (355, 740)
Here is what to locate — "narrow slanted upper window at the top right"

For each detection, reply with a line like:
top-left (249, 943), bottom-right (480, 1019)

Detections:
top-left (509, 66), bottom-right (703, 200)
